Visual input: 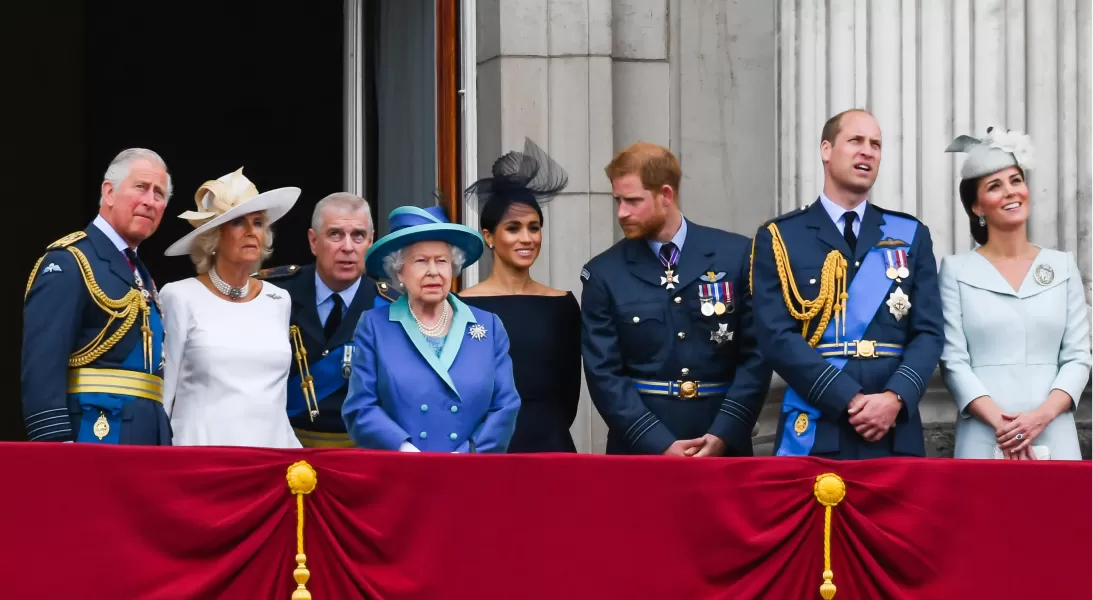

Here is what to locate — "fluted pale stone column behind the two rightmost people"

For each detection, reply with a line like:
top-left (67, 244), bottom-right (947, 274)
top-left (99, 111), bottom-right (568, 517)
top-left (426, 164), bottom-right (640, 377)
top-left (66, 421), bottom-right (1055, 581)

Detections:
top-left (778, 0), bottom-right (1093, 454)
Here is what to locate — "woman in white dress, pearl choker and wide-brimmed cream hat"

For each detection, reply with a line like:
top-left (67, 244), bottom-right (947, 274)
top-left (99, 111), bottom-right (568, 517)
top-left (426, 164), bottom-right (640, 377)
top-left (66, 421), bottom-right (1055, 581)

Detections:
top-left (160, 168), bottom-right (301, 448)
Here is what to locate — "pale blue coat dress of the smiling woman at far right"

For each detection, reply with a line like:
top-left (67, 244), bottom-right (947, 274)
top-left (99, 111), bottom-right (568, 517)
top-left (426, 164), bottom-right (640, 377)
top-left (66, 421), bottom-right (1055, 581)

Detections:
top-left (940, 248), bottom-right (1090, 460)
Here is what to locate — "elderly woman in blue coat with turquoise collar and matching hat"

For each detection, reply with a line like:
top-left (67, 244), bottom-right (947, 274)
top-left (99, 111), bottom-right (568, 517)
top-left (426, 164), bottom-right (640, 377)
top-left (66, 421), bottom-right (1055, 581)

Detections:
top-left (342, 207), bottom-right (520, 452)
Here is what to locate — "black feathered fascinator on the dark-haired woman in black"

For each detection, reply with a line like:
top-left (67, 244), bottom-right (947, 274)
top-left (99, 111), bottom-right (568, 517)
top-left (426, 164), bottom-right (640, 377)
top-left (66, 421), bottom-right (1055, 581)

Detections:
top-left (467, 138), bottom-right (569, 232)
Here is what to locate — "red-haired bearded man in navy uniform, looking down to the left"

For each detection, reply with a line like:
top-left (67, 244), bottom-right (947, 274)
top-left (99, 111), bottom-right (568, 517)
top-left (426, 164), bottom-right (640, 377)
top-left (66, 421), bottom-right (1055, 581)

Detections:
top-left (580, 142), bottom-right (771, 457)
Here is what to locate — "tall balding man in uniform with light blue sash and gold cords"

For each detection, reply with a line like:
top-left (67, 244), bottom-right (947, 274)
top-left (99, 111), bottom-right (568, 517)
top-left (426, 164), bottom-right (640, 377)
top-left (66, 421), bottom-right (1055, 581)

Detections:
top-left (752, 110), bottom-right (944, 459)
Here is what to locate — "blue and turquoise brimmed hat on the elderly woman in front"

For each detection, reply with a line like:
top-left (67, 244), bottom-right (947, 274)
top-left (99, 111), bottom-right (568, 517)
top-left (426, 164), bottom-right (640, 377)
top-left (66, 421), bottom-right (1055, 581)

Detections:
top-left (364, 207), bottom-right (485, 278)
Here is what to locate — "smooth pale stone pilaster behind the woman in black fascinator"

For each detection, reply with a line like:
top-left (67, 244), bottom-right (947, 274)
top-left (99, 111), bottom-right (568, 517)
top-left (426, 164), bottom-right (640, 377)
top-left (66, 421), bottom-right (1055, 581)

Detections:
top-left (477, 0), bottom-right (614, 452)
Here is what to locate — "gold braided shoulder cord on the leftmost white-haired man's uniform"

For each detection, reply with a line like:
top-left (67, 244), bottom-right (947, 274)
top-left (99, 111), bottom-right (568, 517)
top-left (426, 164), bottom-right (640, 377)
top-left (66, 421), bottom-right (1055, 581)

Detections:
top-left (23, 237), bottom-right (153, 373)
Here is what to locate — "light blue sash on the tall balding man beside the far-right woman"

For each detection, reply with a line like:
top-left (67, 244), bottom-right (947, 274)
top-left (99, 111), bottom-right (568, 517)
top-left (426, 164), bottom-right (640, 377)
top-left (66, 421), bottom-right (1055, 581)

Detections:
top-left (775, 214), bottom-right (918, 456)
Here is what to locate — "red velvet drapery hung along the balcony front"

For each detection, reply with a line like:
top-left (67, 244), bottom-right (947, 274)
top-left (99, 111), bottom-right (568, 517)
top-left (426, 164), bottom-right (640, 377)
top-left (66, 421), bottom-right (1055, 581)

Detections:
top-left (0, 444), bottom-right (1093, 600)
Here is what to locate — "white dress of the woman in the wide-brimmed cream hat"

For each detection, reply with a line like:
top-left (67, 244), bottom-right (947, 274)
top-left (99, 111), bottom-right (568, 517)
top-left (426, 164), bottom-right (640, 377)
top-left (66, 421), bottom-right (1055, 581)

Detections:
top-left (160, 278), bottom-right (301, 448)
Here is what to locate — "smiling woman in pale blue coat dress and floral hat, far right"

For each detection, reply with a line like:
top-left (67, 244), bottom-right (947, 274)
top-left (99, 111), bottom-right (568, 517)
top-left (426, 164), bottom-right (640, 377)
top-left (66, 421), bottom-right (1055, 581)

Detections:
top-left (940, 129), bottom-right (1091, 460)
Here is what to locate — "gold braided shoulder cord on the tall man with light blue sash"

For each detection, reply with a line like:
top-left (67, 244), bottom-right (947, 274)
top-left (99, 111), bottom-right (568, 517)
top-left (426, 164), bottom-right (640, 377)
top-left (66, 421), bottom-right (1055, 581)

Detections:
top-left (752, 223), bottom-right (849, 348)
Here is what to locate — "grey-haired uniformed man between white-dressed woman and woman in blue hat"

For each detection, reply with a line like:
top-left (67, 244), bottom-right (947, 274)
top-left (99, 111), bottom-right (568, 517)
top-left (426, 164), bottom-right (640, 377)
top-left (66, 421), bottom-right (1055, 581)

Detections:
top-left (258, 192), bottom-right (399, 448)
